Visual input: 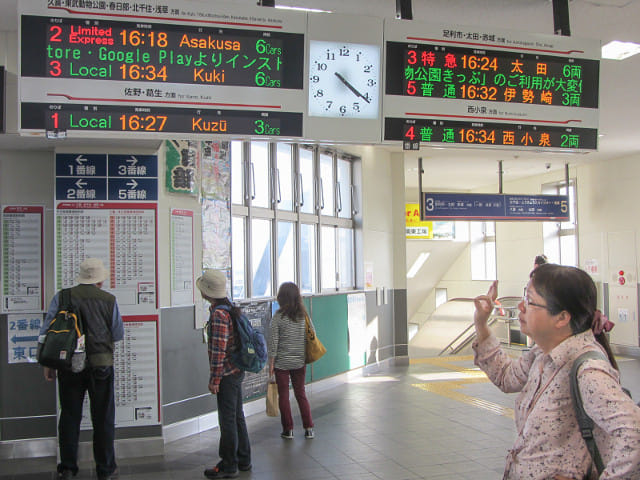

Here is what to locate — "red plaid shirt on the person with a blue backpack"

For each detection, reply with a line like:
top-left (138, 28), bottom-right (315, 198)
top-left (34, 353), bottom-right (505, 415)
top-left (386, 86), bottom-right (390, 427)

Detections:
top-left (207, 306), bottom-right (240, 385)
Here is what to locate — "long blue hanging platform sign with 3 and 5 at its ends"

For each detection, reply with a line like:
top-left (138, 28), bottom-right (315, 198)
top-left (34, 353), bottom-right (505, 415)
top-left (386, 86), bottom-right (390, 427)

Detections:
top-left (420, 192), bottom-right (569, 221)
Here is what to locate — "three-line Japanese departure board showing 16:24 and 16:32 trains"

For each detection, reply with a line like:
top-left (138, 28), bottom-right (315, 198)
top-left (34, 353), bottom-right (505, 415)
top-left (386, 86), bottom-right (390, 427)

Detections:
top-left (386, 42), bottom-right (600, 108)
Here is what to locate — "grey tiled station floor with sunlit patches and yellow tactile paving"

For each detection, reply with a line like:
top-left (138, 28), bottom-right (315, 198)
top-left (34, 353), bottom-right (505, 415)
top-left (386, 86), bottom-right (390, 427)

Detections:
top-left (0, 356), bottom-right (640, 480)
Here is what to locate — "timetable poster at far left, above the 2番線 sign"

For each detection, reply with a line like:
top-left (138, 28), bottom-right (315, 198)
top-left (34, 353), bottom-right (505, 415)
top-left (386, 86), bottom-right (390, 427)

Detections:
top-left (0, 205), bottom-right (44, 313)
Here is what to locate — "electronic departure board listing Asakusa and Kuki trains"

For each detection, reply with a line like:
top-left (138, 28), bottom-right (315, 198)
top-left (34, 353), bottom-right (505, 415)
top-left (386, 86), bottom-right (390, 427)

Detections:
top-left (21, 15), bottom-right (304, 90)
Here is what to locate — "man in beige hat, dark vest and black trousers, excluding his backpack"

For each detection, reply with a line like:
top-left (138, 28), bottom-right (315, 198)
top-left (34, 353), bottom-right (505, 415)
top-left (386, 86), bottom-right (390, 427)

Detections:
top-left (40, 258), bottom-right (124, 480)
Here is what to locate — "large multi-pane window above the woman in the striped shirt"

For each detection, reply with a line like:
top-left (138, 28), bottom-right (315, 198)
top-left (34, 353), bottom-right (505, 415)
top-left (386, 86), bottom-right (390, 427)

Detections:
top-left (226, 141), bottom-right (358, 299)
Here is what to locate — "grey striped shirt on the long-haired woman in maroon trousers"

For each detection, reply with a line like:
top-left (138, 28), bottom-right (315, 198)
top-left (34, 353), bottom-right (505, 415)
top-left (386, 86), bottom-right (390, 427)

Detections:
top-left (268, 310), bottom-right (305, 370)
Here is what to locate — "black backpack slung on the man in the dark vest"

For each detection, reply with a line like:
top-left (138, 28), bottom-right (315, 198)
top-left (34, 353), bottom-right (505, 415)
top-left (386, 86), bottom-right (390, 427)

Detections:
top-left (38, 288), bottom-right (86, 372)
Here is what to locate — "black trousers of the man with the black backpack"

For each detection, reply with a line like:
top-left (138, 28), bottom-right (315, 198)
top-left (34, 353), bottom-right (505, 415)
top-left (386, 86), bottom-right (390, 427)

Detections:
top-left (58, 367), bottom-right (116, 477)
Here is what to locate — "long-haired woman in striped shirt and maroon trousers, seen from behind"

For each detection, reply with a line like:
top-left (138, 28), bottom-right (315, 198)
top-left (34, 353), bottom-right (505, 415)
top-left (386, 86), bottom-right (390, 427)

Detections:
top-left (269, 282), bottom-right (314, 439)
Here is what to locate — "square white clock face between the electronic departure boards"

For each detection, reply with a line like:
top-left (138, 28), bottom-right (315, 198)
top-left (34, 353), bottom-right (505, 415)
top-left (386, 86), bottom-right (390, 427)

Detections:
top-left (309, 40), bottom-right (380, 118)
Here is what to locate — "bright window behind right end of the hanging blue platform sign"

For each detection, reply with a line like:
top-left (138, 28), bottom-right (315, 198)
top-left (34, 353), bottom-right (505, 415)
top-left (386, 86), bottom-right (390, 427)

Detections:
top-left (542, 180), bottom-right (578, 267)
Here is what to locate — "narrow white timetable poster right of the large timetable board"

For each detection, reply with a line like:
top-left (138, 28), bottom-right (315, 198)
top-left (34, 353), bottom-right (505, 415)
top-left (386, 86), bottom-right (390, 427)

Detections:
top-left (171, 208), bottom-right (194, 306)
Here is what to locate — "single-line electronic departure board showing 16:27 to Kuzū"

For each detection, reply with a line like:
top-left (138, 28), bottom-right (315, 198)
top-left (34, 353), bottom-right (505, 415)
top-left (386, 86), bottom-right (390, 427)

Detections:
top-left (21, 103), bottom-right (302, 137)
